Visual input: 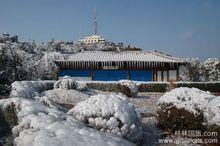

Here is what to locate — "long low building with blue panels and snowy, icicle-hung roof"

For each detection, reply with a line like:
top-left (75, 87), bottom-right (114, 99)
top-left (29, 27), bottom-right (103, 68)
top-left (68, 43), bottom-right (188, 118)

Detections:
top-left (55, 51), bottom-right (185, 81)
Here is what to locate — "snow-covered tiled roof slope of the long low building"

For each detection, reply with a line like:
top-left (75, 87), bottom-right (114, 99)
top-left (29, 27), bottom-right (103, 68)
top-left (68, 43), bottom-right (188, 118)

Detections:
top-left (59, 51), bottom-right (184, 63)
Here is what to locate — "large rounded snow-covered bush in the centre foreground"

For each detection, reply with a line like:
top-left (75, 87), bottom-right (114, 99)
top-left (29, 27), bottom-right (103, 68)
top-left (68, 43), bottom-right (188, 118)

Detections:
top-left (68, 93), bottom-right (142, 142)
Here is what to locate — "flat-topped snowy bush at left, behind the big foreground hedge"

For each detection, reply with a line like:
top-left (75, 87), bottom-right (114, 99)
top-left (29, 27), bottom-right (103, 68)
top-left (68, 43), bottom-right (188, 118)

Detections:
top-left (10, 81), bottom-right (55, 98)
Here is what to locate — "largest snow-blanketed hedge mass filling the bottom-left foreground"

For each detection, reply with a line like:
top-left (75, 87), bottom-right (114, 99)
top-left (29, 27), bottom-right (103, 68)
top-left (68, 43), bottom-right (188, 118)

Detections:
top-left (0, 98), bottom-right (133, 146)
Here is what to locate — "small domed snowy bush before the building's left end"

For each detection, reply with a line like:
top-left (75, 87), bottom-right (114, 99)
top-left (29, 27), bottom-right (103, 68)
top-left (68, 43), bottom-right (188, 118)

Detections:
top-left (54, 77), bottom-right (77, 89)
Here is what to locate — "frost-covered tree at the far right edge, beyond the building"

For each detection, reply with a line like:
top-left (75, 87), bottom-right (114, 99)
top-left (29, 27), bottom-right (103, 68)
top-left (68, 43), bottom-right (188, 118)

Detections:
top-left (203, 58), bottom-right (220, 81)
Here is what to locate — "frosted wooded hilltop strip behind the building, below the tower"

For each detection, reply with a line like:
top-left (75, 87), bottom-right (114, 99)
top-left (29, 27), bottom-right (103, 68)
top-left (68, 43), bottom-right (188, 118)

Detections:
top-left (0, 33), bottom-right (141, 52)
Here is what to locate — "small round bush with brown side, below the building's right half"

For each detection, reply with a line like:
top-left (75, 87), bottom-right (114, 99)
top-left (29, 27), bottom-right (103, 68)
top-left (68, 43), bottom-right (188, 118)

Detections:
top-left (118, 80), bottom-right (138, 97)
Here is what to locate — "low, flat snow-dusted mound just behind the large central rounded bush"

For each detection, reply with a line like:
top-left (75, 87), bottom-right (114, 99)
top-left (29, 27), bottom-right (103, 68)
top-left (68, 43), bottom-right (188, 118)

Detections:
top-left (43, 88), bottom-right (89, 106)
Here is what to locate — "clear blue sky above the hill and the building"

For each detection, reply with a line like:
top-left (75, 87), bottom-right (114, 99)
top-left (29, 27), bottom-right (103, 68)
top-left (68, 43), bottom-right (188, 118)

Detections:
top-left (0, 0), bottom-right (220, 60)
